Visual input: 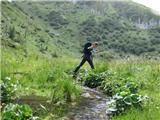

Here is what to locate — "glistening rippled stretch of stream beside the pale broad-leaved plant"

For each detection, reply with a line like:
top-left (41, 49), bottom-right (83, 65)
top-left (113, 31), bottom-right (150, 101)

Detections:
top-left (66, 87), bottom-right (109, 120)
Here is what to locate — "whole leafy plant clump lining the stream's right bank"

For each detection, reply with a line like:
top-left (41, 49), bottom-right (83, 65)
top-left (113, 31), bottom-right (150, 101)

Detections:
top-left (84, 70), bottom-right (148, 114)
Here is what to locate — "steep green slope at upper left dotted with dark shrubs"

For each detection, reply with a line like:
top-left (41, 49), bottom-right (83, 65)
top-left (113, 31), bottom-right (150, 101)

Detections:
top-left (1, 2), bottom-right (75, 57)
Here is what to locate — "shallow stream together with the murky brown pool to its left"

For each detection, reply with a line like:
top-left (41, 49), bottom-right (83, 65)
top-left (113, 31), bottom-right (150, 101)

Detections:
top-left (15, 86), bottom-right (109, 120)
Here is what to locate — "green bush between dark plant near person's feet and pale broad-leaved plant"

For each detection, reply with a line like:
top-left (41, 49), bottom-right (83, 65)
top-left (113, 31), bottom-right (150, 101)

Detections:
top-left (100, 71), bottom-right (140, 96)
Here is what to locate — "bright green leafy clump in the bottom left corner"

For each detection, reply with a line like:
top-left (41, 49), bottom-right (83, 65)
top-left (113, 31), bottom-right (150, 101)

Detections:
top-left (2, 103), bottom-right (40, 120)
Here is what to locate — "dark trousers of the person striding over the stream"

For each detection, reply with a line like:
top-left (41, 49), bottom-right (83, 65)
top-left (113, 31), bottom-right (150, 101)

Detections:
top-left (74, 55), bottom-right (94, 74)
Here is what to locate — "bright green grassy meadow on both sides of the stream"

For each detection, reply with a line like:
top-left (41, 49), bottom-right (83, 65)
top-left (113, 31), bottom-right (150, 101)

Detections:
top-left (1, 48), bottom-right (160, 120)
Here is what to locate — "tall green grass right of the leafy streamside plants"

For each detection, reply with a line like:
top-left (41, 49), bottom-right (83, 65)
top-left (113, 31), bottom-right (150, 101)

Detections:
top-left (104, 60), bottom-right (160, 120)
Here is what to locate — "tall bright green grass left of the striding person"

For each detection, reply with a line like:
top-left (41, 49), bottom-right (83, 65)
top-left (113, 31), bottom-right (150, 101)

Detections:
top-left (1, 49), bottom-right (79, 100)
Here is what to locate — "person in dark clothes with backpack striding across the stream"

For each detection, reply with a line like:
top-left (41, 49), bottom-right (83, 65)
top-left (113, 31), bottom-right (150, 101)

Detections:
top-left (73, 42), bottom-right (98, 77)
